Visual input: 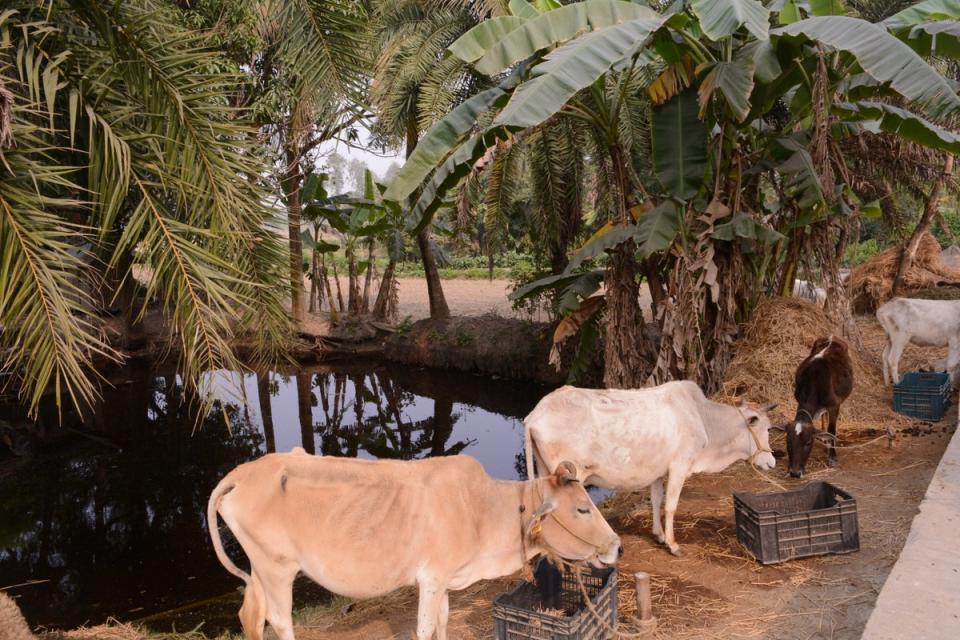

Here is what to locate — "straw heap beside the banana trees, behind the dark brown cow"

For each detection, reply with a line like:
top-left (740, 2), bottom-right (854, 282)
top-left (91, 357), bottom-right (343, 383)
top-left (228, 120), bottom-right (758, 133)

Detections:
top-left (717, 298), bottom-right (943, 432)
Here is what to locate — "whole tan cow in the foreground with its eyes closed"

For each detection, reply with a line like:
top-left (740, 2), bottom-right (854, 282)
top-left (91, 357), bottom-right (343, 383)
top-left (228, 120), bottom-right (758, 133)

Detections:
top-left (207, 449), bottom-right (622, 640)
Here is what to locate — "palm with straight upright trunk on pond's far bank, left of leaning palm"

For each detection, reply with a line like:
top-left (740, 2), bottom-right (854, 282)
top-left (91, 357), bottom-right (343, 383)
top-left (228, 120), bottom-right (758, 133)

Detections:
top-left (245, 0), bottom-right (371, 322)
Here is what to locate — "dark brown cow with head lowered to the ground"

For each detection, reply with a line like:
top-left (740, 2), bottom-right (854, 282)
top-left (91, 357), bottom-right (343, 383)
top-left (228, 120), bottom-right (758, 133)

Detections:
top-left (785, 336), bottom-right (853, 478)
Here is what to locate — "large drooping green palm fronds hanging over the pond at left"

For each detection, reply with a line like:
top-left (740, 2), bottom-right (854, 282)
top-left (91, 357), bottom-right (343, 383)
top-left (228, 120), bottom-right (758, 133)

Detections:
top-left (0, 0), bottom-right (288, 416)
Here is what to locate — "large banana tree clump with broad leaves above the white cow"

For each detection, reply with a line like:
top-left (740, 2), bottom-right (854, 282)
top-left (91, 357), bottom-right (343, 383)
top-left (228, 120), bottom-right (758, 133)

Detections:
top-left (386, 0), bottom-right (960, 388)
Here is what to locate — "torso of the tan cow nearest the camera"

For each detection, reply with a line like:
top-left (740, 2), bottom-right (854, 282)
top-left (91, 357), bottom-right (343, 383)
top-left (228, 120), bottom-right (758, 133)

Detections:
top-left (221, 453), bottom-right (493, 597)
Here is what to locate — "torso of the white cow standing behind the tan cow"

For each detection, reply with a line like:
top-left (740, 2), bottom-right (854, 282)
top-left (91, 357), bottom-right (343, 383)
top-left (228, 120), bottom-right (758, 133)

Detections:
top-left (524, 381), bottom-right (706, 489)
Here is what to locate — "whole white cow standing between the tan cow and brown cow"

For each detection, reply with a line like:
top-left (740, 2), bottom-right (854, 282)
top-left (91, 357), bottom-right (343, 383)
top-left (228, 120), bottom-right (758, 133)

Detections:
top-left (524, 381), bottom-right (776, 555)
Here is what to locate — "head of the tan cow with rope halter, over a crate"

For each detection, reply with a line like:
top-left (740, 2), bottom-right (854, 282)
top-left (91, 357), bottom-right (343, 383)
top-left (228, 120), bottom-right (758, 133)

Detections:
top-left (525, 462), bottom-right (623, 566)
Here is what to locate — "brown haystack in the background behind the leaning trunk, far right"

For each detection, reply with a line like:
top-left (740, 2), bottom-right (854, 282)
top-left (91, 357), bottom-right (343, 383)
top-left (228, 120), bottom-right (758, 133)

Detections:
top-left (849, 233), bottom-right (960, 313)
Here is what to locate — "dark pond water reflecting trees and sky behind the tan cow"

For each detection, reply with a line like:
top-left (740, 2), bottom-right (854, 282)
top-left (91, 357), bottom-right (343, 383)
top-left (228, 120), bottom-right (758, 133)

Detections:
top-left (0, 363), bottom-right (547, 633)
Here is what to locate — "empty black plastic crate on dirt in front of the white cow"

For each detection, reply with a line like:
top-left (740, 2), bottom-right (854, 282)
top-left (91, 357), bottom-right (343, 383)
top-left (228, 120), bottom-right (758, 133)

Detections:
top-left (733, 480), bottom-right (860, 564)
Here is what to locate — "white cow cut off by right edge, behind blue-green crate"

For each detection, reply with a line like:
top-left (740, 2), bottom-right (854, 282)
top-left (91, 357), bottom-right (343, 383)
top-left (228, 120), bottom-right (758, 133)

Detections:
top-left (877, 298), bottom-right (960, 384)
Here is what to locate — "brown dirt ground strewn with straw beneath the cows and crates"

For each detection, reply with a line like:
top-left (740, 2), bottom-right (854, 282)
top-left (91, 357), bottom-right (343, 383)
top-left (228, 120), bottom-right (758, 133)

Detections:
top-left (288, 404), bottom-right (957, 640)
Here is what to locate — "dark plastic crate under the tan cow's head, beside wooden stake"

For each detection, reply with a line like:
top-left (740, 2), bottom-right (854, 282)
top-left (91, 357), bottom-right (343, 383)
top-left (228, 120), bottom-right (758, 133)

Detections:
top-left (493, 560), bottom-right (617, 640)
